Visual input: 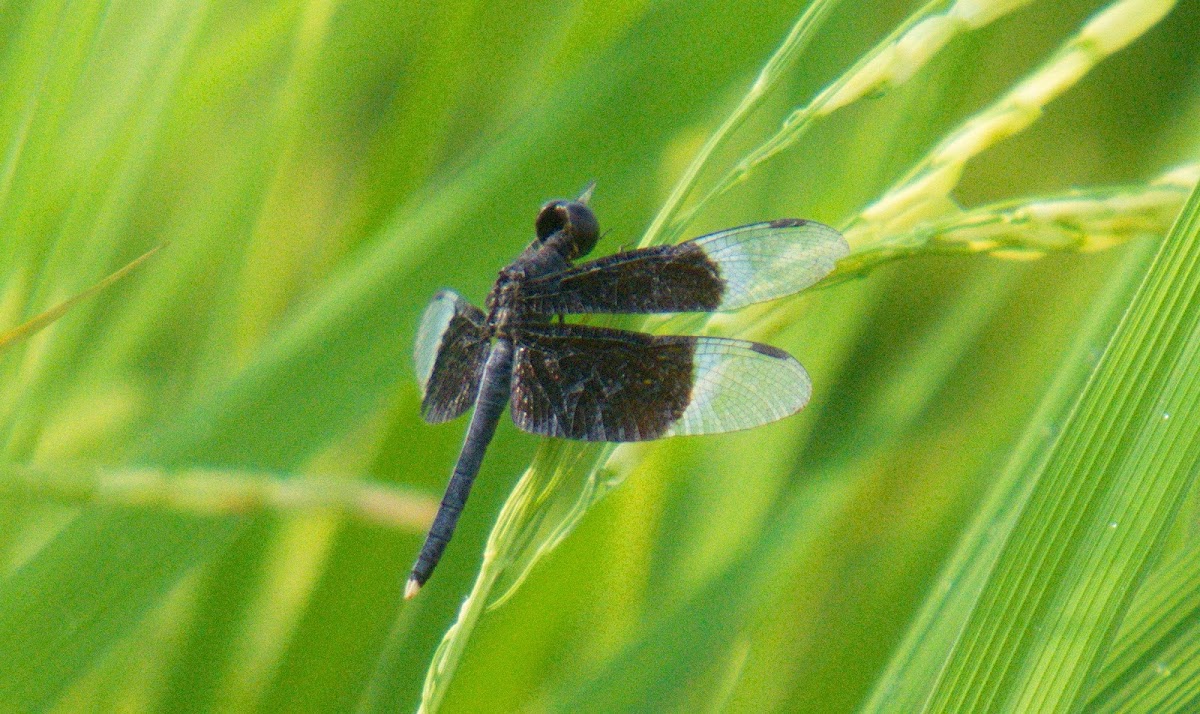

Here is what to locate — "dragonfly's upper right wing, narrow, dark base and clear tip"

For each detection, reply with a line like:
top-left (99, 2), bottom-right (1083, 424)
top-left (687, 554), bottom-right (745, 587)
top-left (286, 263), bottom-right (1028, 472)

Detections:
top-left (521, 218), bottom-right (850, 314)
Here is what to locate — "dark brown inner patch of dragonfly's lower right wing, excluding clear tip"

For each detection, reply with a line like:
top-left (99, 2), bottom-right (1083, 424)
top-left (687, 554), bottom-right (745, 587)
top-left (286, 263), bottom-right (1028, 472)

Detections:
top-left (511, 325), bottom-right (697, 442)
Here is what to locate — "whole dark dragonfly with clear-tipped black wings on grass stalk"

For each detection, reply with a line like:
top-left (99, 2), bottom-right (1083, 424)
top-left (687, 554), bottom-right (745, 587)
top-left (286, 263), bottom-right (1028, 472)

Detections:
top-left (404, 186), bottom-right (850, 599)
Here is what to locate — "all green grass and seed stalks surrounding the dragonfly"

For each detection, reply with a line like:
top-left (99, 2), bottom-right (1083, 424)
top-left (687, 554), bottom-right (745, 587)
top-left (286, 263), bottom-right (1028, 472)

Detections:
top-left (0, 0), bottom-right (1200, 712)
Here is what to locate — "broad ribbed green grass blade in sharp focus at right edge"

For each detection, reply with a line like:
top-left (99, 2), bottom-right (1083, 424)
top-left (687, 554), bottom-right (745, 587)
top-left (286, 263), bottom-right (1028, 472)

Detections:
top-left (907, 177), bottom-right (1200, 712)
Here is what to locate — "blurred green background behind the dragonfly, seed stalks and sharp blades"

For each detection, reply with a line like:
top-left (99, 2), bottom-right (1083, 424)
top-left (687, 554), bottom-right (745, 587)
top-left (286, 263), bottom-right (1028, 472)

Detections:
top-left (0, 0), bottom-right (1200, 712)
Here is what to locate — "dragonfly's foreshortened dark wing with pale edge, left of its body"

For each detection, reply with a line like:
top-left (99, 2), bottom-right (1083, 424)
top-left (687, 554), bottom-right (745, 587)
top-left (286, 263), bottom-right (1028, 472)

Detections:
top-left (413, 290), bottom-right (491, 424)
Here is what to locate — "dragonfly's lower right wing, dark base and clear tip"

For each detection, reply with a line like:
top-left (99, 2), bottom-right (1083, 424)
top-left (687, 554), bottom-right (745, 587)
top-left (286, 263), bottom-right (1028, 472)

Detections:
top-left (512, 325), bottom-right (811, 442)
